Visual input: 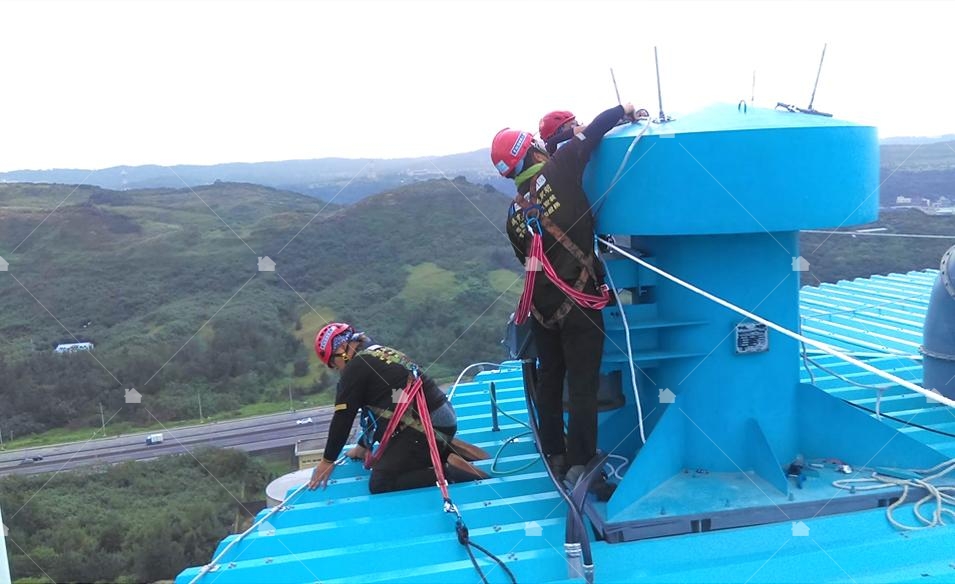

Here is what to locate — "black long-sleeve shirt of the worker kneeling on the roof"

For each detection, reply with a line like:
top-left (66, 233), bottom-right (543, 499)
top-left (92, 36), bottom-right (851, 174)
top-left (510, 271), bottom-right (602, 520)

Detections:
top-left (323, 345), bottom-right (448, 461)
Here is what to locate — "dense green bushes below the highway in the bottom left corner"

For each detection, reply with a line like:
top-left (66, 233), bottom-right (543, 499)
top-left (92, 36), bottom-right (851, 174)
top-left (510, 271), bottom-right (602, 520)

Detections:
top-left (0, 449), bottom-right (270, 582)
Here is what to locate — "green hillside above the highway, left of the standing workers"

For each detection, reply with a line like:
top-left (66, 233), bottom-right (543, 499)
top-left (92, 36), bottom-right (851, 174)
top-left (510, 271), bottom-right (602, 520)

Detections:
top-left (0, 179), bottom-right (521, 436)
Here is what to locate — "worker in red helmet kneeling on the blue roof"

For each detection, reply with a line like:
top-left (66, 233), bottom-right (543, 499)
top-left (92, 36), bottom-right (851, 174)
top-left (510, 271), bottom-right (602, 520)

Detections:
top-left (309, 323), bottom-right (486, 493)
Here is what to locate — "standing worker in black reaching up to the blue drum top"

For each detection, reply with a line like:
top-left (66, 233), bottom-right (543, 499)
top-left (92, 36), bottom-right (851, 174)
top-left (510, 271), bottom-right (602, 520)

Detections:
top-left (491, 103), bottom-right (634, 500)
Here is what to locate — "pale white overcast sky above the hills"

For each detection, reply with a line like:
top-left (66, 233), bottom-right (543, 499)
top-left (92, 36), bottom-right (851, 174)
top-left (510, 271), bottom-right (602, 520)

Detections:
top-left (0, 0), bottom-right (955, 171)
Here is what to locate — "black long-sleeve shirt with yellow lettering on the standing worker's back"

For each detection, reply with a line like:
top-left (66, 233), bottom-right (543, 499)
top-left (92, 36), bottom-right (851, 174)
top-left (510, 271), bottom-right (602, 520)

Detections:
top-left (507, 106), bottom-right (624, 318)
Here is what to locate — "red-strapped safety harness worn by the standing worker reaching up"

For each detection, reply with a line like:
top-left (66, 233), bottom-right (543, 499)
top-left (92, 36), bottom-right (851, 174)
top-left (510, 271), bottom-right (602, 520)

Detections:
top-left (514, 174), bottom-right (610, 328)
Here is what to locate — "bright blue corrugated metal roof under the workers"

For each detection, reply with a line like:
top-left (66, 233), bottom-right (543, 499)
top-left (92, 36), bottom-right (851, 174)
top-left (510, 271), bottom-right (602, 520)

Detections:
top-left (176, 270), bottom-right (955, 584)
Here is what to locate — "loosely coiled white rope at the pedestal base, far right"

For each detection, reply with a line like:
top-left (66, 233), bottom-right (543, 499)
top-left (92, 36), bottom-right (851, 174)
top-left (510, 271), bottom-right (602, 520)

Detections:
top-left (832, 460), bottom-right (955, 531)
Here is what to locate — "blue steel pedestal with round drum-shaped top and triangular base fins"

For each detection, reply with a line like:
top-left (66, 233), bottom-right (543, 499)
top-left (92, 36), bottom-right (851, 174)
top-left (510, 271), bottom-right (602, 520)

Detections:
top-left (586, 101), bottom-right (944, 541)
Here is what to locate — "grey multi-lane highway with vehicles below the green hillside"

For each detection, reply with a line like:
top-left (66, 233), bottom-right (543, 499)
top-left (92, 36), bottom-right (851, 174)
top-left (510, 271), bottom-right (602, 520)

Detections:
top-left (0, 406), bottom-right (332, 477)
